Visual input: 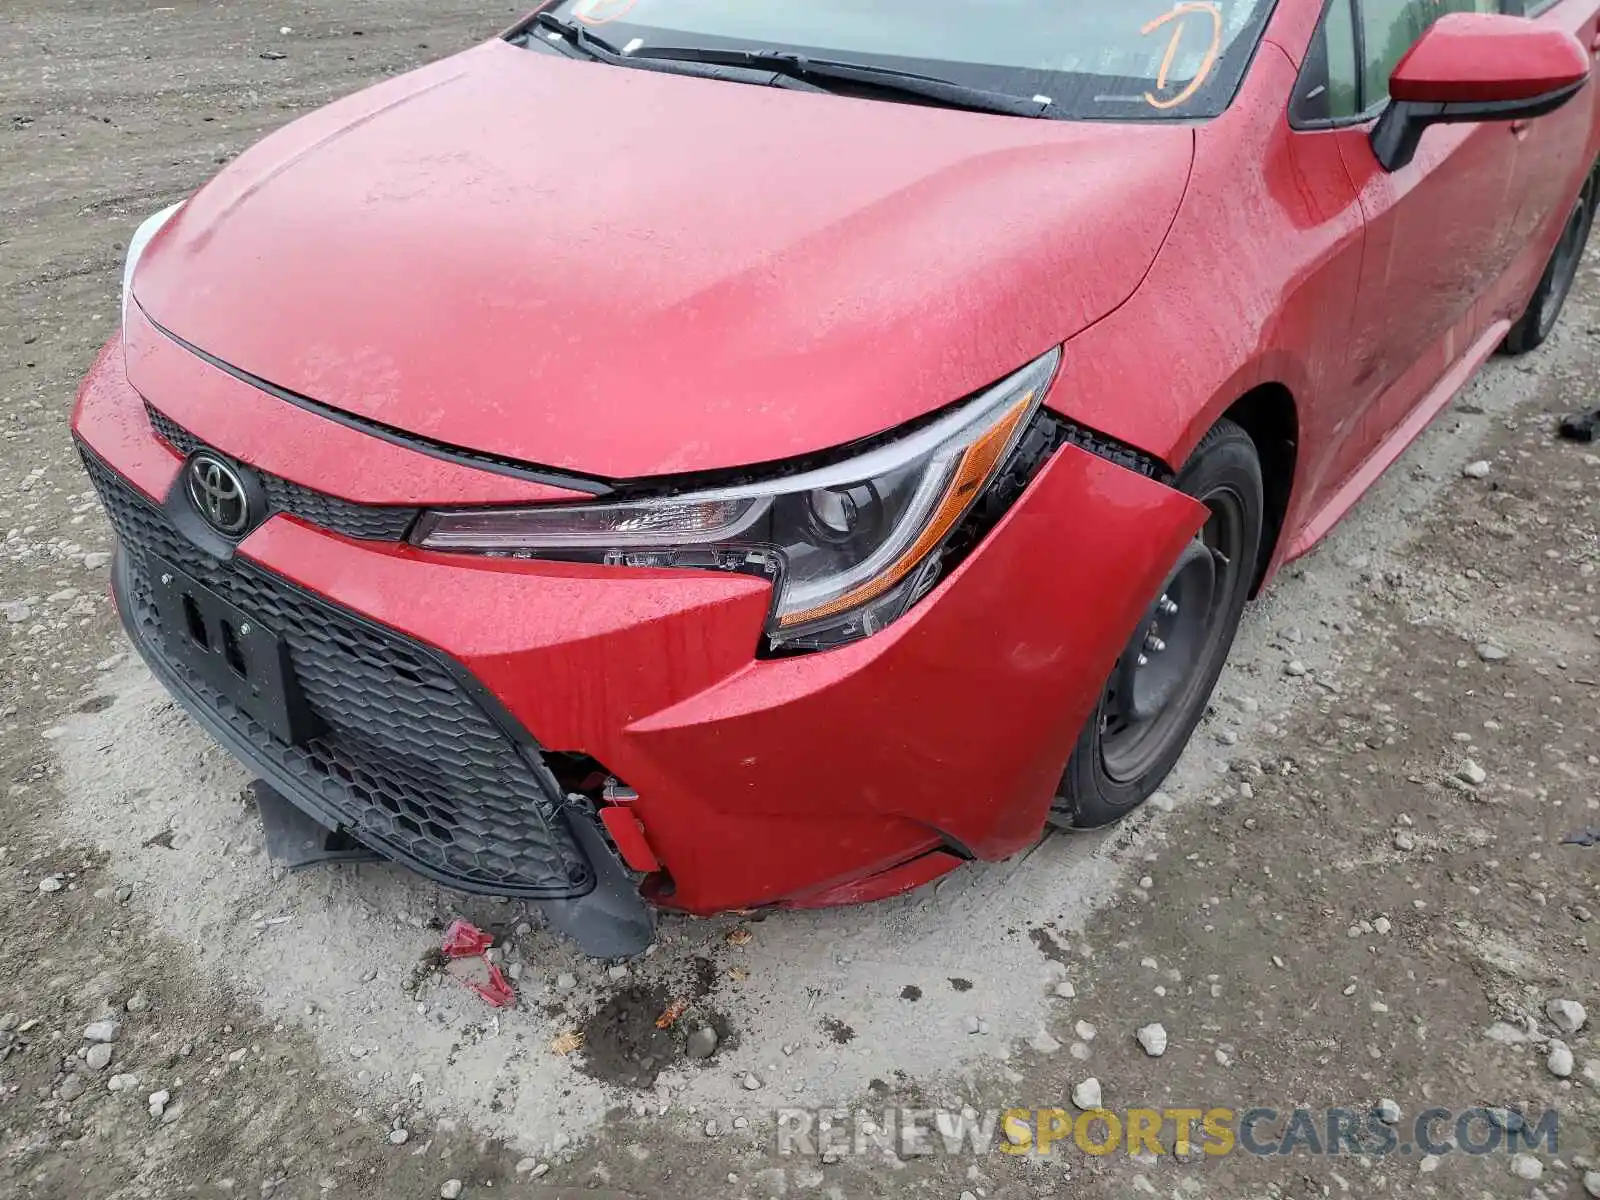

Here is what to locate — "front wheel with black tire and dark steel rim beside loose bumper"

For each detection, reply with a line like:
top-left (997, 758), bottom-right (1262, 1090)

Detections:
top-left (1050, 419), bottom-right (1266, 829)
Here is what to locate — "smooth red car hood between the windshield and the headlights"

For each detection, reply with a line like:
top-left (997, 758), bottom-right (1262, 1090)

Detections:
top-left (134, 42), bottom-right (1194, 478)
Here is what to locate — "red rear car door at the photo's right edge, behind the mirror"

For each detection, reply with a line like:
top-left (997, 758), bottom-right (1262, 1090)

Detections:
top-left (1496, 0), bottom-right (1600, 302)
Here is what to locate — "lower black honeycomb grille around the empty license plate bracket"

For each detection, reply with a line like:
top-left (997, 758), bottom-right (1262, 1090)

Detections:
top-left (83, 451), bottom-right (594, 898)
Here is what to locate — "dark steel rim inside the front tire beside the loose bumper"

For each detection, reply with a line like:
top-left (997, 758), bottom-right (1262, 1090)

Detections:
top-left (1098, 486), bottom-right (1245, 782)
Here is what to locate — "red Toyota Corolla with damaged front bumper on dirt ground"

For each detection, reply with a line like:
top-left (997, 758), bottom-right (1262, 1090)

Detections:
top-left (74, 0), bottom-right (1600, 955)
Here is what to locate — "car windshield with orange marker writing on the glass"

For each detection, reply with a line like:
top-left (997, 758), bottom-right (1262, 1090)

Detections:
top-left (547, 0), bottom-right (1274, 120)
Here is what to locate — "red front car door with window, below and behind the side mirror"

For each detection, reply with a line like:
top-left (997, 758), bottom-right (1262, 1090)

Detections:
top-left (1290, 0), bottom-right (1516, 490)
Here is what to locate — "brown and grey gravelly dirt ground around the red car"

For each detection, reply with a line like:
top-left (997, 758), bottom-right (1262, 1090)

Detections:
top-left (0, 0), bottom-right (1600, 1200)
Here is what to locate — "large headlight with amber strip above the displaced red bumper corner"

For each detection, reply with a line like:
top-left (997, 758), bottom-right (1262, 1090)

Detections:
top-left (414, 350), bottom-right (1061, 650)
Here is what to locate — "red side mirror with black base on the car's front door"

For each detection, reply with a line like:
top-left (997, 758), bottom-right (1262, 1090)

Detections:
top-left (1373, 13), bottom-right (1589, 171)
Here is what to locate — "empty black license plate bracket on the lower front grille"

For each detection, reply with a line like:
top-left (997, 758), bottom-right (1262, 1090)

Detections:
top-left (150, 558), bottom-right (322, 744)
